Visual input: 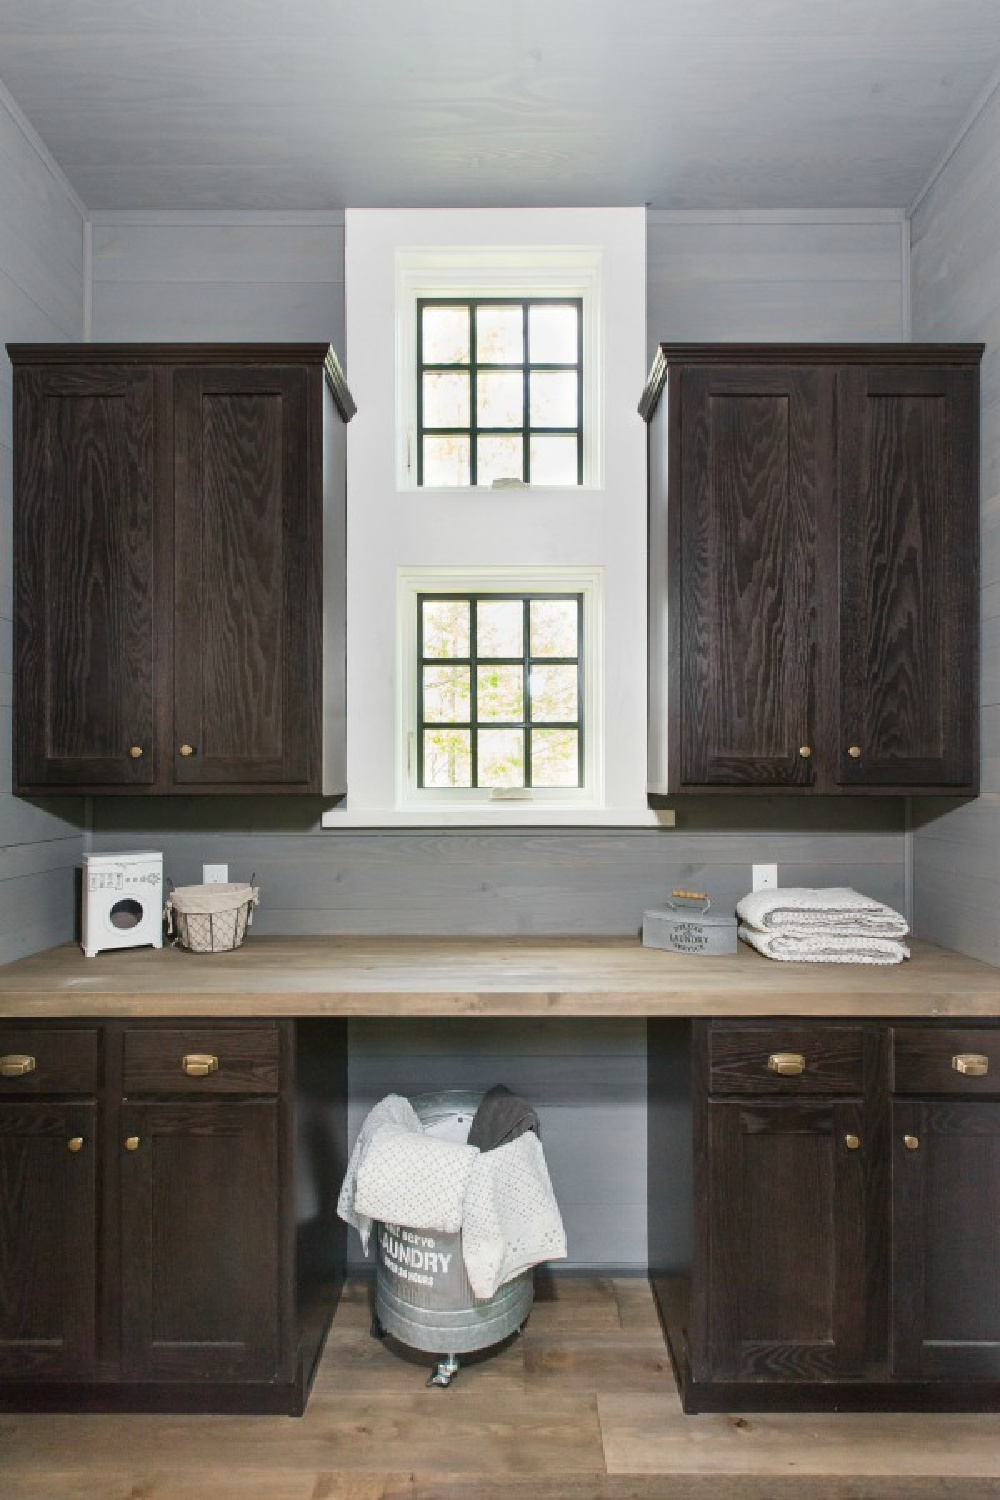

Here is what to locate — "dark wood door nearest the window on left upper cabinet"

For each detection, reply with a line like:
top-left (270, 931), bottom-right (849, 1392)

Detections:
top-left (171, 368), bottom-right (322, 791)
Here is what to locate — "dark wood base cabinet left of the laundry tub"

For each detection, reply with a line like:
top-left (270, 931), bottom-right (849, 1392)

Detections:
top-left (0, 1020), bottom-right (346, 1413)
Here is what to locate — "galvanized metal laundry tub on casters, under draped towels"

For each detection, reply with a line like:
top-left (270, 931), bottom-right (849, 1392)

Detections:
top-left (372, 1089), bottom-right (535, 1385)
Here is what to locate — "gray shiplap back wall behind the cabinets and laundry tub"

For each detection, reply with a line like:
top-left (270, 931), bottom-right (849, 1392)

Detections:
top-left (93, 213), bottom-right (906, 1268)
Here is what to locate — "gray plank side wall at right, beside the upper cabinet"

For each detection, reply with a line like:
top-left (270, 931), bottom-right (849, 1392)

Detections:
top-left (912, 95), bottom-right (1000, 965)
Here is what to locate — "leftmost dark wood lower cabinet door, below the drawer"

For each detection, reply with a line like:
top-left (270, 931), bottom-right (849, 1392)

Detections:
top-left (0, 1103), bottom-right (97, 1380)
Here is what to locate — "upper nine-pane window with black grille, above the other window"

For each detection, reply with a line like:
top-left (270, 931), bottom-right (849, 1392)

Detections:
top-left (417, 297), bottom-right (583, 488)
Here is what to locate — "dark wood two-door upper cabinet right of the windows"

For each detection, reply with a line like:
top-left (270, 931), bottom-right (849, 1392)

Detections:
top-left (640, 345), bottom-right (982, 794)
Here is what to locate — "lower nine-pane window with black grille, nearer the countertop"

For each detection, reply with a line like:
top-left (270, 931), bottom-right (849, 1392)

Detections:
top-left (417, 593), bottom-right (585, 789)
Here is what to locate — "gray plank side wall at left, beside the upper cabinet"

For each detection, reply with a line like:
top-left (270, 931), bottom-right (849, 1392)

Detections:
top-left (0, 90), bottom-right (85, 963)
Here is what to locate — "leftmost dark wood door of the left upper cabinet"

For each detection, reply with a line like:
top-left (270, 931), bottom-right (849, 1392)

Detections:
top-left (13, 365), bottom-right (154, 791)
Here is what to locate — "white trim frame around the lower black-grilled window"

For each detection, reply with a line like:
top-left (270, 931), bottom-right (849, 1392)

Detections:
top-left (396, 564), bottom-right (604, 821)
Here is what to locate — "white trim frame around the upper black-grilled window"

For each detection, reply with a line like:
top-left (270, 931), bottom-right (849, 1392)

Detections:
top-left (396, 245), bottom-right (604, 495)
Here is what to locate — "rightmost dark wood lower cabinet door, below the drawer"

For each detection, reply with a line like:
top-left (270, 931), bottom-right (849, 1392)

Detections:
top-left (891, 1100), bottom-right (1000, 1380)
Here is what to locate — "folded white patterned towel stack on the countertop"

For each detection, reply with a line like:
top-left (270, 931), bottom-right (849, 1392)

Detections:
top-left (736, 885), bottom-right (910, 963)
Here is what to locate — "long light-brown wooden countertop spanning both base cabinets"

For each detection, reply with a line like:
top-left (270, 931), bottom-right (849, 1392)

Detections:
top-left (0, 935), bottom-right (1000, 1020)
